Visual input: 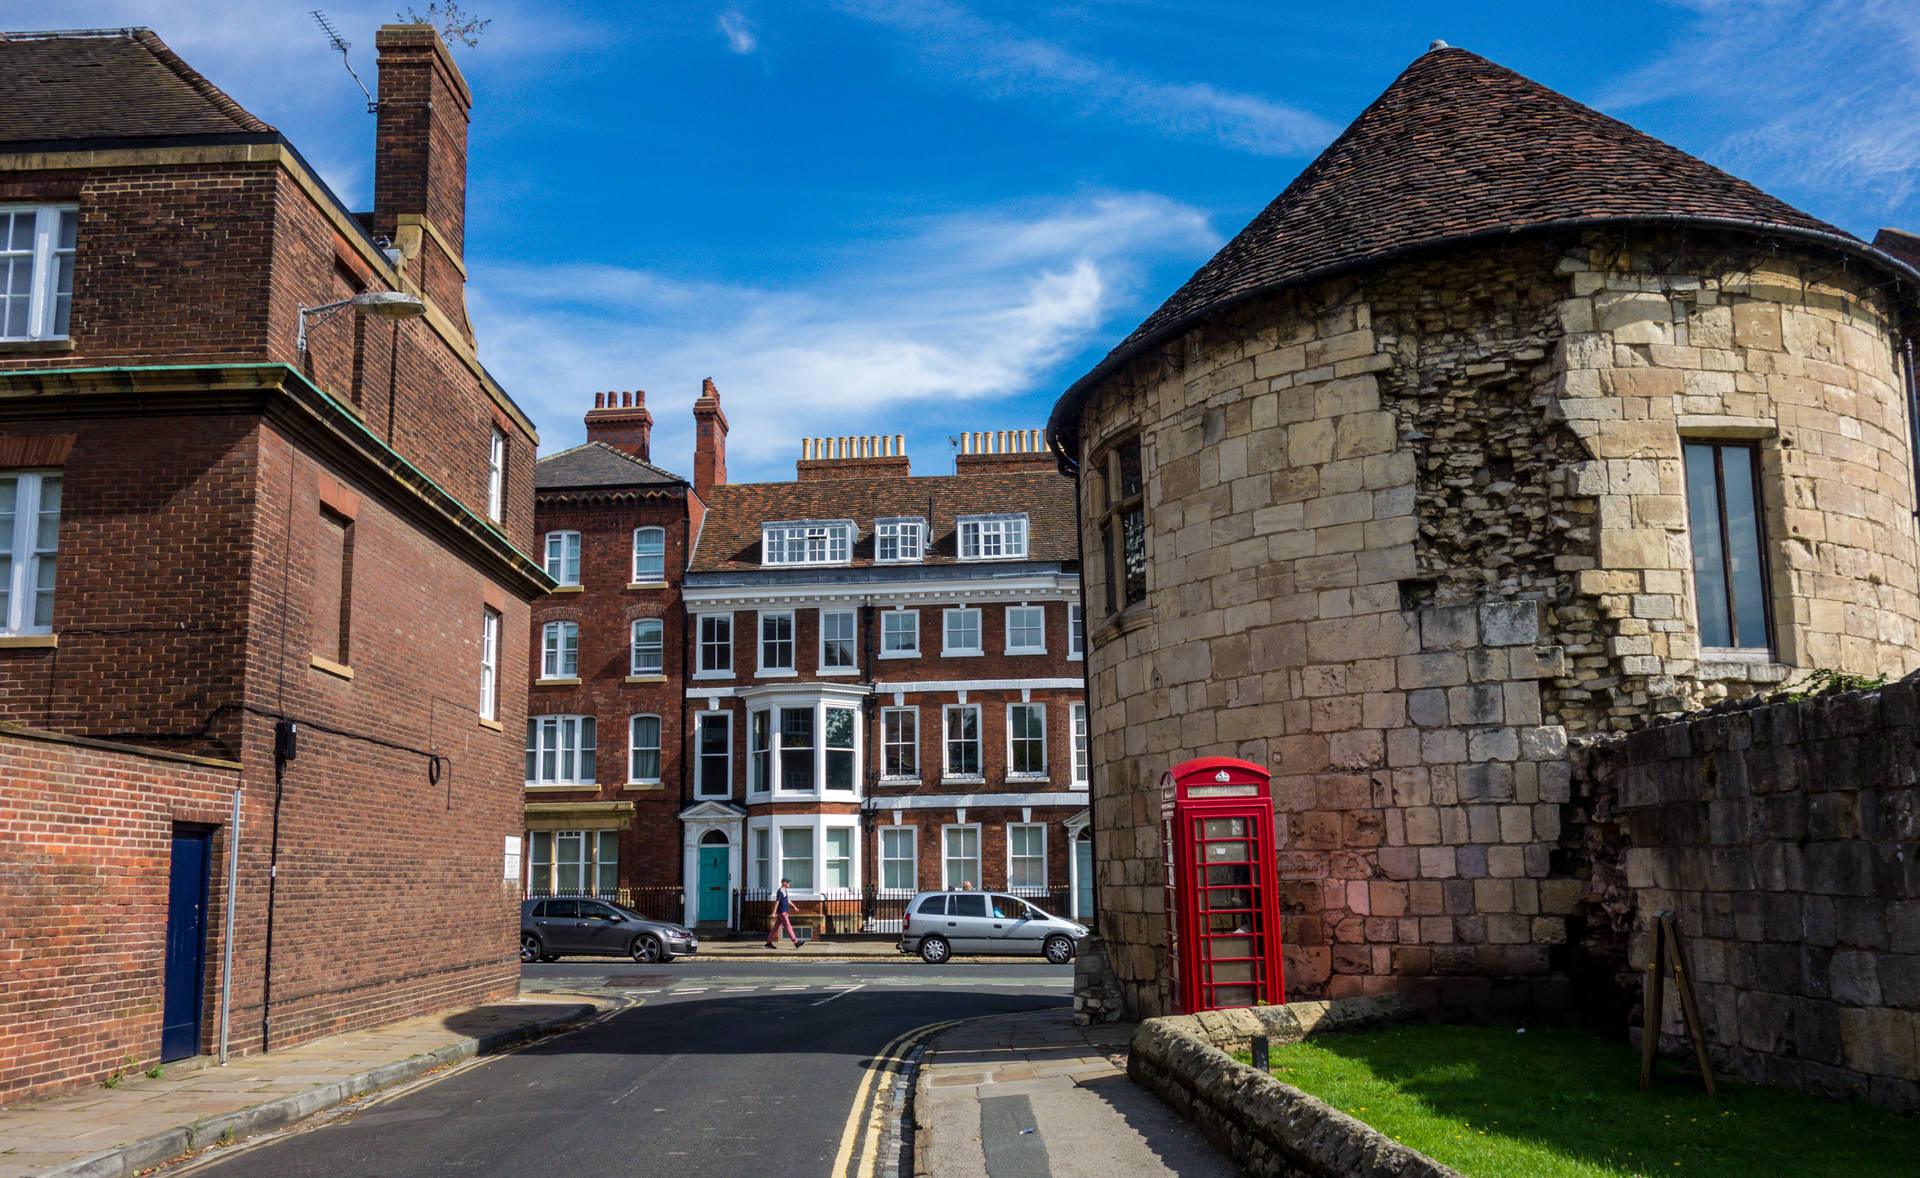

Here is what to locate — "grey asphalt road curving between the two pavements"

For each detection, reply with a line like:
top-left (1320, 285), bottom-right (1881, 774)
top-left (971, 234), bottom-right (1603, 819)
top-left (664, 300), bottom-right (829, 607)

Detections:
top-left (178, 957), bottom-right (1073, 1178)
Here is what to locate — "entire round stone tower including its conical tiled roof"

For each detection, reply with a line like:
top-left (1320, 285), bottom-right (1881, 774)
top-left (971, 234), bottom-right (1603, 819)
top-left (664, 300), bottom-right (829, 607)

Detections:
top-left (1050, 44), bottom-right (1920, 1013)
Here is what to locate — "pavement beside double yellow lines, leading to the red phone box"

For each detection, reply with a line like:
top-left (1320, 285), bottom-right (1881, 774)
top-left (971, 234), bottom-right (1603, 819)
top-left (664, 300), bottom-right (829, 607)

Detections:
top-left (914, 1007), bottom-right (1240, 1178)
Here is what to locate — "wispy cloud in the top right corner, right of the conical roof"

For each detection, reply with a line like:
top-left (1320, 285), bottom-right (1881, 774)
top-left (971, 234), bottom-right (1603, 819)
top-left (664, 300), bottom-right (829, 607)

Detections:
top-left (1599, 0), bottom-right (1920, 216)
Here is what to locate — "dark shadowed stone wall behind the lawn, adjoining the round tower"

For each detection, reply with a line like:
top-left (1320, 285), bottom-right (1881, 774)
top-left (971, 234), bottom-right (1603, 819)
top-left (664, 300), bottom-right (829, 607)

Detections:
top-left (1576, 677), bottom-right (1920, 1113)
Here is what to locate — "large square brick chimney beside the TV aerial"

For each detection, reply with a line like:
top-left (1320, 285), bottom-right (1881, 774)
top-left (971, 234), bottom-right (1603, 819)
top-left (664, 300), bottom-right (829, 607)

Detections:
top-left (369, 25), bottom-right (474, 342)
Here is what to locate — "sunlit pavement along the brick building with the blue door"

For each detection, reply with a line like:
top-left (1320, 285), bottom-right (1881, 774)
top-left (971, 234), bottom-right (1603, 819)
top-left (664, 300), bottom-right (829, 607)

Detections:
top-left (0, 994), bottom-right (618, 1178)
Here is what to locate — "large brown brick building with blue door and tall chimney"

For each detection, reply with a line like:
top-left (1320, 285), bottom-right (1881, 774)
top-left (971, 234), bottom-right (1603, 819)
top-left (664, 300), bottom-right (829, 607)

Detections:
top-left (0, 25), bottom-right (549, 1099)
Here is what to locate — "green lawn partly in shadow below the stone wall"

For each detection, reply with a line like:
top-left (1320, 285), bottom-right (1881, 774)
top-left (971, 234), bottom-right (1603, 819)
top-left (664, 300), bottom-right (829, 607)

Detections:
top-left (1240, 1025), bottom-right (1920, 1178)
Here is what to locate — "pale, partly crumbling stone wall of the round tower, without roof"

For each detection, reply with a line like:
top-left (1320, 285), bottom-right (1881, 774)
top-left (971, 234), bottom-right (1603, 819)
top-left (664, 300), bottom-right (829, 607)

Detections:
top-left (1079, 238), bottom-right (1920, 1013)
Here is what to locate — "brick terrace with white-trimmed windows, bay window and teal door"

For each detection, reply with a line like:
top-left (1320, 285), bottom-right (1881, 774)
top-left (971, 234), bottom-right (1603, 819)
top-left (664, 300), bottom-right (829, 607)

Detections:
top-left (682, 429), bottom-right (1091, 932)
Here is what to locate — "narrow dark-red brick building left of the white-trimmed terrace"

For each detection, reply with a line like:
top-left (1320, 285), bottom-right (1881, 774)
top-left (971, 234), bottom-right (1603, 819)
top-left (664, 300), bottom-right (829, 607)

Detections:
top-left (526, 393), bottom-right (697, 921)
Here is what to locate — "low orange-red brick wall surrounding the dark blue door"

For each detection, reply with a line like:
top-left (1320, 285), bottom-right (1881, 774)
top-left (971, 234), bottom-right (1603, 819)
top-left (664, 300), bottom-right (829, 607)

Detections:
top-left (0, 733), bottom-right (240, 1101)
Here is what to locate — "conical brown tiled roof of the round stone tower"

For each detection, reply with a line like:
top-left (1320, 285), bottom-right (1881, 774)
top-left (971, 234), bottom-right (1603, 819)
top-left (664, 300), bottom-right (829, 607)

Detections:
top-left (1048, 46), bottom-right (1912, 453)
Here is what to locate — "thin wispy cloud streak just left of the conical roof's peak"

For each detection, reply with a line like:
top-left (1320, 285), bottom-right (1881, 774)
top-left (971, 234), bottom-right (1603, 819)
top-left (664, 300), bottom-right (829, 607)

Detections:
top-left (841, 0), bottom-right (1338, 155)
